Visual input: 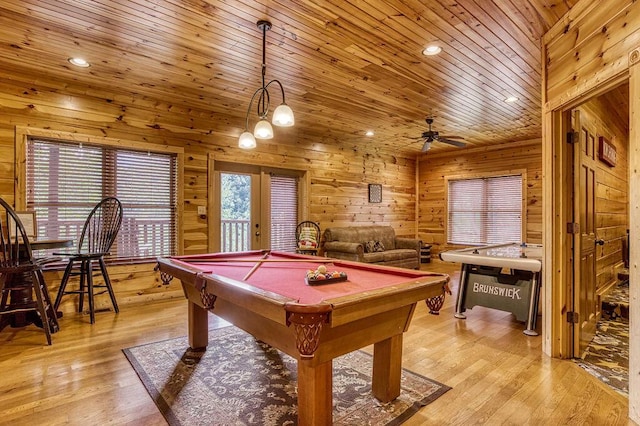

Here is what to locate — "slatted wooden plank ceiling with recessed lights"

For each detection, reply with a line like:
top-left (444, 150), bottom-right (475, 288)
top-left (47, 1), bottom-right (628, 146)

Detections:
top-left (0, 0), bottom-right (577, 156)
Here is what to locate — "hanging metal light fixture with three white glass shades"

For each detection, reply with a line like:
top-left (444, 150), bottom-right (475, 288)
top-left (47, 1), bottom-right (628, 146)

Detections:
top-left (238, 20), bottom-right (295, 149)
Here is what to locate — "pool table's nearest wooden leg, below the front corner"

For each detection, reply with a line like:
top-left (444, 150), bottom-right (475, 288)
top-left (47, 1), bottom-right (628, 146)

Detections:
top-left (298, 359), bottom-right (333, 426)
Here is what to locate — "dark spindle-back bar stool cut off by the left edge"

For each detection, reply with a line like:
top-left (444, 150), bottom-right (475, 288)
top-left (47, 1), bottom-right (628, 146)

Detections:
top-left (0, 198), bottom-right (58, 345)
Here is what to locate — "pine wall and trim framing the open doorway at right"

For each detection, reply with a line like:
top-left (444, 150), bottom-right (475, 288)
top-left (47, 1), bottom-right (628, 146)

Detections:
top-left (542, 0), bottom-right (640, 423)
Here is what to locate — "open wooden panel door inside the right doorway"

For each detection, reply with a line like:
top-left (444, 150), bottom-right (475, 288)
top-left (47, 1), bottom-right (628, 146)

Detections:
top-left (572, 110), bottom-right (599, 356)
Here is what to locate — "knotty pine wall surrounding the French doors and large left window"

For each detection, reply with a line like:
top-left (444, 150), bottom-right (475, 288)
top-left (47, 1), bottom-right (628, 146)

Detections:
top-left (0, 76), bottom-right (416, 311)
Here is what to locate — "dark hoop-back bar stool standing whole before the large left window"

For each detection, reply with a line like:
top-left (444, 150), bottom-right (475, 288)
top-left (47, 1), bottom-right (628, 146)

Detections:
top-left (54, 197), bottom-right (122, 324)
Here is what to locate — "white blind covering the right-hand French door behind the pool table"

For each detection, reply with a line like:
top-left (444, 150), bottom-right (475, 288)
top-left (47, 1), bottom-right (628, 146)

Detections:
top-left (271, 175), bottom-right (298, 252)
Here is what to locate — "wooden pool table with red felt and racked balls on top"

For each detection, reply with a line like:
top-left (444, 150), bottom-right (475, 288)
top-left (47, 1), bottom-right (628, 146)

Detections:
top-left (158, 251), bottom-right (449, 425)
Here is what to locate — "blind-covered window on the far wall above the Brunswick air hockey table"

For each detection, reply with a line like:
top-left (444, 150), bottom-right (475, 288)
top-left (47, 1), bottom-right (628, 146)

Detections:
top-left (447, 175), bottom-right (522, 245)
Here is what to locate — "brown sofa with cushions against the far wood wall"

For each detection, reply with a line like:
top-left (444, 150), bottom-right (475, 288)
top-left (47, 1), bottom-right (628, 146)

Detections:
top-left (319, 226), bottom-right (422, 269)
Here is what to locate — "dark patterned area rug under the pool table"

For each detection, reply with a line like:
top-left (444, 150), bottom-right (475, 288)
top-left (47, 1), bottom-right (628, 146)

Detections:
top-left (123, 327), bottom-right (450, 426)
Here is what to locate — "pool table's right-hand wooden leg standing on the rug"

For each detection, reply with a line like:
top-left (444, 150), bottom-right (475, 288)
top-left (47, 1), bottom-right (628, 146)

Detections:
top-left (371, 333), bottom-right (402, 402)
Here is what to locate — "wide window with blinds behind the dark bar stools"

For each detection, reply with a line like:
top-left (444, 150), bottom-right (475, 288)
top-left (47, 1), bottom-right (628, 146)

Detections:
top-left (26, 138), bottom-right (178, 259)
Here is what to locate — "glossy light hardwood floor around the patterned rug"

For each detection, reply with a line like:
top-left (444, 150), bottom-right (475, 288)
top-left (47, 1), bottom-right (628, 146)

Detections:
top-left (0, 261), bottom-right (634, 425)
